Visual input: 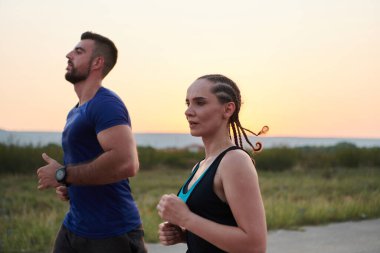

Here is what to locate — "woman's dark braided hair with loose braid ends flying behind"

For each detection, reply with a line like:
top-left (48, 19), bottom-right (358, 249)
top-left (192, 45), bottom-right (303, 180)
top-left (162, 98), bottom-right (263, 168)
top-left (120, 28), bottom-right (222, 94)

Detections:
top-left (197, 74), bottom-right (269, 153)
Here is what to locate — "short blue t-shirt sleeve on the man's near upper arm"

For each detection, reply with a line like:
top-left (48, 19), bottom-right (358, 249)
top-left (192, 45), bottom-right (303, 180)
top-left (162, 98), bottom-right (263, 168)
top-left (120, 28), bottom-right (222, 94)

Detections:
top-left (87, 93), bottom-right (131, 134)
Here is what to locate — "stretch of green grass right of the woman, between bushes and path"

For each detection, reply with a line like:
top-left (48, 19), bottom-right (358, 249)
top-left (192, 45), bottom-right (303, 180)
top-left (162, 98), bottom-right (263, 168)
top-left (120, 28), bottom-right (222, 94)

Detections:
top-left (260, 169), bottom-right (380, 229)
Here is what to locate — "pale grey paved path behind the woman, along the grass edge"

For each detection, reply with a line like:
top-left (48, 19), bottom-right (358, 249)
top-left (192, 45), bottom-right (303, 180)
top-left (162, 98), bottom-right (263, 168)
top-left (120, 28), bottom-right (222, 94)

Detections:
top-left (147, 219), bottom-right (380, 253)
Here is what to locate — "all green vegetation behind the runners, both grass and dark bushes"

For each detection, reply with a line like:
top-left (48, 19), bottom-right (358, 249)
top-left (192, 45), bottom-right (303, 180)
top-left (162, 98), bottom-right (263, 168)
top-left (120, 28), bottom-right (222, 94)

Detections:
top-left (0, 143), bottom-right (380, 252)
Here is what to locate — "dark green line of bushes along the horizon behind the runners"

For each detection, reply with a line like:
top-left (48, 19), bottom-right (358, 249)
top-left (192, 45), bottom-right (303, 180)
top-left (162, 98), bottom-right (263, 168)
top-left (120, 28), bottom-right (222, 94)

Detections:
top-left (0, 143), bottom-right (380, 174)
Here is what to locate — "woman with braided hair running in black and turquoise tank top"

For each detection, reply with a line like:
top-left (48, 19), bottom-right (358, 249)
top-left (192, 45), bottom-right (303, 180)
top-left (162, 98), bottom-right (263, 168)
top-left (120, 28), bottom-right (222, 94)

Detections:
top-left (157, 75), bottom-right (268, 253)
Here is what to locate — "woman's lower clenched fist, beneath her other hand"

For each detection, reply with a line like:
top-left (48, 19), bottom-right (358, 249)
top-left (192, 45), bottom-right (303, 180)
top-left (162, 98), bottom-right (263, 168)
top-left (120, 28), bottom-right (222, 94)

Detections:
top-left (158, 222), bottom-right (186, 246)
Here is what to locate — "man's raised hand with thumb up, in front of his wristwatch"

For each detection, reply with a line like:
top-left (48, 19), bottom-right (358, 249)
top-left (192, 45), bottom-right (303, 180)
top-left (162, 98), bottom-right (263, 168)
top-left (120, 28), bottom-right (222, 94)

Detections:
top-left (37, 153), bottom-right (62, 190)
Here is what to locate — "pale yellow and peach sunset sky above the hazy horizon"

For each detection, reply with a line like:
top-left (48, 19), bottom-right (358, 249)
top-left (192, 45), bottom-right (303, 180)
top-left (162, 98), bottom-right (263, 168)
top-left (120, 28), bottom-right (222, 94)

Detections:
top-left (0, 0), bottom-right (380, 138)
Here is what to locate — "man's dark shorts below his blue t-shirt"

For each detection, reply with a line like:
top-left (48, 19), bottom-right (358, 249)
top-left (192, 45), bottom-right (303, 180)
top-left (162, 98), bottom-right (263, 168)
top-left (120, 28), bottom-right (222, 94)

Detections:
top-left (53, 225), bottom-right (147, 253)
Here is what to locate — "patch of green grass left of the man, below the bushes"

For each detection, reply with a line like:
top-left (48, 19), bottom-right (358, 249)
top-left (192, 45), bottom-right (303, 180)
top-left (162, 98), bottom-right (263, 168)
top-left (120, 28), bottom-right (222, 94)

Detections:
top-left (0, 175), bottom-right (68, 253)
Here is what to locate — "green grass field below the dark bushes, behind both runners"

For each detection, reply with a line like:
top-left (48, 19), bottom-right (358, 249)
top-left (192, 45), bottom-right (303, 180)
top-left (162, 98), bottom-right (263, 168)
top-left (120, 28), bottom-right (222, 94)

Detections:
top-left (0, 168), bottom-right (380, 252)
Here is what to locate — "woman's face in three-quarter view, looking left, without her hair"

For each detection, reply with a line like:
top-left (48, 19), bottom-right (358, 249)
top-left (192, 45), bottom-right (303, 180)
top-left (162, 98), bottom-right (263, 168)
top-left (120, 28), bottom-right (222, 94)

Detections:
top-left (185, 79), bottom-right (228, 137)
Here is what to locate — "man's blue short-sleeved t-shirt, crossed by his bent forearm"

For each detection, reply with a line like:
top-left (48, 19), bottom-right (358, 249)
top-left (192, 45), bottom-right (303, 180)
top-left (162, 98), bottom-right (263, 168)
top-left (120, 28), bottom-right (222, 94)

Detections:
top-left (62, 87), bottom-right (141, 239)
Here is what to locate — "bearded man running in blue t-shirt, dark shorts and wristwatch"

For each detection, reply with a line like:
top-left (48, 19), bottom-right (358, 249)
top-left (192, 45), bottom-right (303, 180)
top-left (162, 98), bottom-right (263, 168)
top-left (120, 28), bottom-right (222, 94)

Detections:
top-left (37, 32), bottom-right (146, 253)
